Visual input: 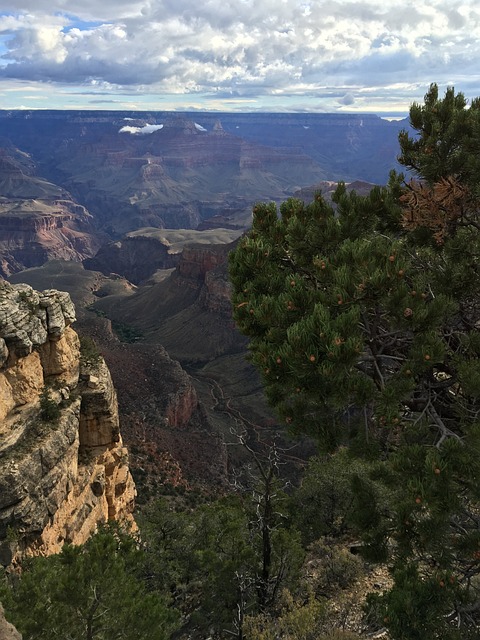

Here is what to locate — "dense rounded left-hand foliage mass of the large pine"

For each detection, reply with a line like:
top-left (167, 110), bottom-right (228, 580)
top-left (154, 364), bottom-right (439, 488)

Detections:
top-left (230, 181), bottom-right (416, 448)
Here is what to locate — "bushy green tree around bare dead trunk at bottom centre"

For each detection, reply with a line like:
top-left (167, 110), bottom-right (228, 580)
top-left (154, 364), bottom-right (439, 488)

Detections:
top-left (142, 466), bottom-right (304, 633)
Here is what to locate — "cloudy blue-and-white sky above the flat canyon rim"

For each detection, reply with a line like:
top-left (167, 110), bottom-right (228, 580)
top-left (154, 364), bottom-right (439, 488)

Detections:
top-left (0, 0), bottom-right (480, 116)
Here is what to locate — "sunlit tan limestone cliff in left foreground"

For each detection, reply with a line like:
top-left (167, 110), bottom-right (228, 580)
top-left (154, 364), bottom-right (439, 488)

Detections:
top-left (0, 281), bottom-right (135, 565)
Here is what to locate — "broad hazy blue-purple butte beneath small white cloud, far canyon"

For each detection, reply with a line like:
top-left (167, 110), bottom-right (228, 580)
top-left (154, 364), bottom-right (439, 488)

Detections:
top-left (0, 115), bottom-right (327, 240)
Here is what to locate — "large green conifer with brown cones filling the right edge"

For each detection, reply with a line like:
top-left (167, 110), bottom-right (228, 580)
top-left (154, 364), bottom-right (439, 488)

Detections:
top-left (230, 85), bottom-right (480, 640)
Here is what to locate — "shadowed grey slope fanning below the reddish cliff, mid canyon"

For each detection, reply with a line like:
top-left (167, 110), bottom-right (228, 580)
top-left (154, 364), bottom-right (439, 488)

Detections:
top-left (95, 244), bottom-right (245, 365)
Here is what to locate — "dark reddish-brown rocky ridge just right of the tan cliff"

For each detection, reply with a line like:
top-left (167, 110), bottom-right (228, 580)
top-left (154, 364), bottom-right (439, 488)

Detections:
top-left (96, 338), bottom-right (228, 496)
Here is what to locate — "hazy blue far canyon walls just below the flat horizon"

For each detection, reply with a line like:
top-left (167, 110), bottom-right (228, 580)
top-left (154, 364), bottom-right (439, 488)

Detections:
top-left (0, 110), bottom-right (405, 278)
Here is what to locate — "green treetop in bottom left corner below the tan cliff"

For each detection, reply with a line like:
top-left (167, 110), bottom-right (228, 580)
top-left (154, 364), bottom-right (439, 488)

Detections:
top-left (0, 529), bottom-right (178, 640)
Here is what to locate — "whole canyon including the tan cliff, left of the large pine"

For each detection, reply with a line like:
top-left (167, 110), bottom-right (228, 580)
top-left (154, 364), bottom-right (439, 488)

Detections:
top-left (0, 111), bottom-right (404, 563)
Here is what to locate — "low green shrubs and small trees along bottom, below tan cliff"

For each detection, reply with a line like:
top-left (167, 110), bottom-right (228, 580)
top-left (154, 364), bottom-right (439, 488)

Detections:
top-left (0, 447), bottom-right (376, 640)
